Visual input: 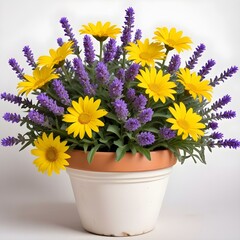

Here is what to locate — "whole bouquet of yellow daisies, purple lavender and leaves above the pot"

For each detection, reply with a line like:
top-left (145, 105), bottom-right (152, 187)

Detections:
top-left (0, 7), bottom-right (240, 175)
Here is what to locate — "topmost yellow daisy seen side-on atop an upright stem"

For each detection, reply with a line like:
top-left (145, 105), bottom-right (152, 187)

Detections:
top-left (79, 21), bottom-right (121, 42)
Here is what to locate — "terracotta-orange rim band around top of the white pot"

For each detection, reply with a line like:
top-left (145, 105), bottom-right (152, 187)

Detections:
top-left (67, 149), bottom-right (177, 172)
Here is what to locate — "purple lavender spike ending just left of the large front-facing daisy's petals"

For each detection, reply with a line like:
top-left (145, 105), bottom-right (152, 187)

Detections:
top-left (37, 93), bottom-right (64, 116)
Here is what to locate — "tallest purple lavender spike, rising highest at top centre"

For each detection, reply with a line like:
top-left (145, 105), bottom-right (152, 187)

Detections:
top-left (121, 7), bottom-right (134, 47)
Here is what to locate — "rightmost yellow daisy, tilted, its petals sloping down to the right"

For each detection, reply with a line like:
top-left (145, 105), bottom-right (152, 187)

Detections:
top-left (177, 68), bottom-right (213, 102)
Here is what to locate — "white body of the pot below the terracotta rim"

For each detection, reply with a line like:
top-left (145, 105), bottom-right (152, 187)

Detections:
top-left (67, 167), bottom-right (172, 236)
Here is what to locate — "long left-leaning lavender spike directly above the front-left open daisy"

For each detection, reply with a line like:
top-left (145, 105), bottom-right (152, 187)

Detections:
top-left (73, 58), bottom-right (97, 96)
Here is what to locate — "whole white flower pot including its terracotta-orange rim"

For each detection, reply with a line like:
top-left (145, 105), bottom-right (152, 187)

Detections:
top-left (67, 150), bottom-right (176, 236)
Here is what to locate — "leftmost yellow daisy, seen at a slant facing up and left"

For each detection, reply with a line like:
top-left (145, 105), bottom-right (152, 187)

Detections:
top-left (17, 67), bottom-right (59, 95)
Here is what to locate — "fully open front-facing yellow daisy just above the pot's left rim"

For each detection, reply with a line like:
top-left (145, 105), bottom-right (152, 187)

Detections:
top-left (63, 96), bottom-right (108, 139)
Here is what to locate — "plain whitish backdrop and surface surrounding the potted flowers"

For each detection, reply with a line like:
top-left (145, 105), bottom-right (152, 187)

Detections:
top-left (0, 0), bottom-right (240, 240)
